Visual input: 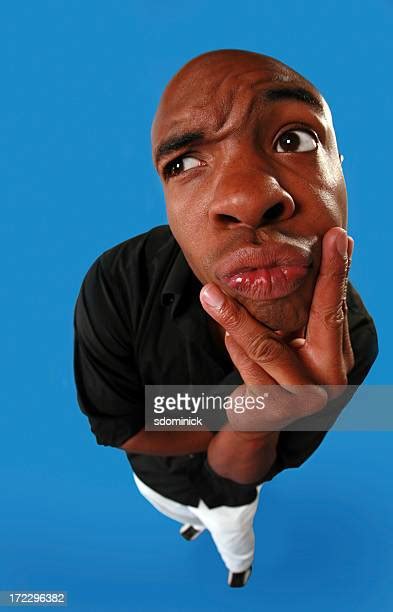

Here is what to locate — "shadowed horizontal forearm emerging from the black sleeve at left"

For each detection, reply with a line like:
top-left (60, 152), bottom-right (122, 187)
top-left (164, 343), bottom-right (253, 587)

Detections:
top-left (119, 430), bottom-right (214, 456)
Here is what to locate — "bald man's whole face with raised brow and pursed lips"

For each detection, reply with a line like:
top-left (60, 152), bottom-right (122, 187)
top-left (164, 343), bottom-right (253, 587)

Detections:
top-left (152, 51), bottom-right (347, 333)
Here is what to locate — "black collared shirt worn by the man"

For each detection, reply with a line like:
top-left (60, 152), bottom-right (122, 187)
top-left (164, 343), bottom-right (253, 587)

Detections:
top-left (74, 225), bottom-right (378, 508)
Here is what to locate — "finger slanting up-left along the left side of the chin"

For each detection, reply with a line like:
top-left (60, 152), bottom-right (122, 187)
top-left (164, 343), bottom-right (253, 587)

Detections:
top-left (200, 283), bottom-right (313, 386)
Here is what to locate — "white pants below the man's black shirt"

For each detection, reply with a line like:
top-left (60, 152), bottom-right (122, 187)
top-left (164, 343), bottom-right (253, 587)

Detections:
top-left (134, 474), bottom-right (262, 572)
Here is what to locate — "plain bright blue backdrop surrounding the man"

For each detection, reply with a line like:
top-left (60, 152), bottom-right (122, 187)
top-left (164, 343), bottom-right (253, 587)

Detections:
top-left (0, 0), bottom-right (393, 612)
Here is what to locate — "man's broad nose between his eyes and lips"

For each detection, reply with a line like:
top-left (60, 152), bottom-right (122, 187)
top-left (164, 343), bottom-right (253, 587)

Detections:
top-left (209, 159), bottom-right (295, 229)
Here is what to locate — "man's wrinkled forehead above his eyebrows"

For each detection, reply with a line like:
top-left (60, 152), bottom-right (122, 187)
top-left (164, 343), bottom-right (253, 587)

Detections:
top-left (151, 56), bottom-right (329, 150)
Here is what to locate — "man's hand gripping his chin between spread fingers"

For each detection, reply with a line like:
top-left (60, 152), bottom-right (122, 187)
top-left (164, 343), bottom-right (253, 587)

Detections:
top-left (200, 227), bottom-right (354, 430)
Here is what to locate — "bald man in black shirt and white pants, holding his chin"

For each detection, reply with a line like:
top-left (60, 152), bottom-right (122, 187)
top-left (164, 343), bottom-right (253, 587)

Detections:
top-left (74, 50), bottom-right (378, 587)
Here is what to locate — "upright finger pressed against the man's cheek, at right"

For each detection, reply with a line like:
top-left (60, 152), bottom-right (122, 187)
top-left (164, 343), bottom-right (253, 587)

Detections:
top-left (306, 227), bottom-right (348, 364)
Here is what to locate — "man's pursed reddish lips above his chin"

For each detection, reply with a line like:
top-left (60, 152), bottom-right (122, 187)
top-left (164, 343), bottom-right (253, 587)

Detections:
top-left (216, 245), bottom-right (312, 301)
